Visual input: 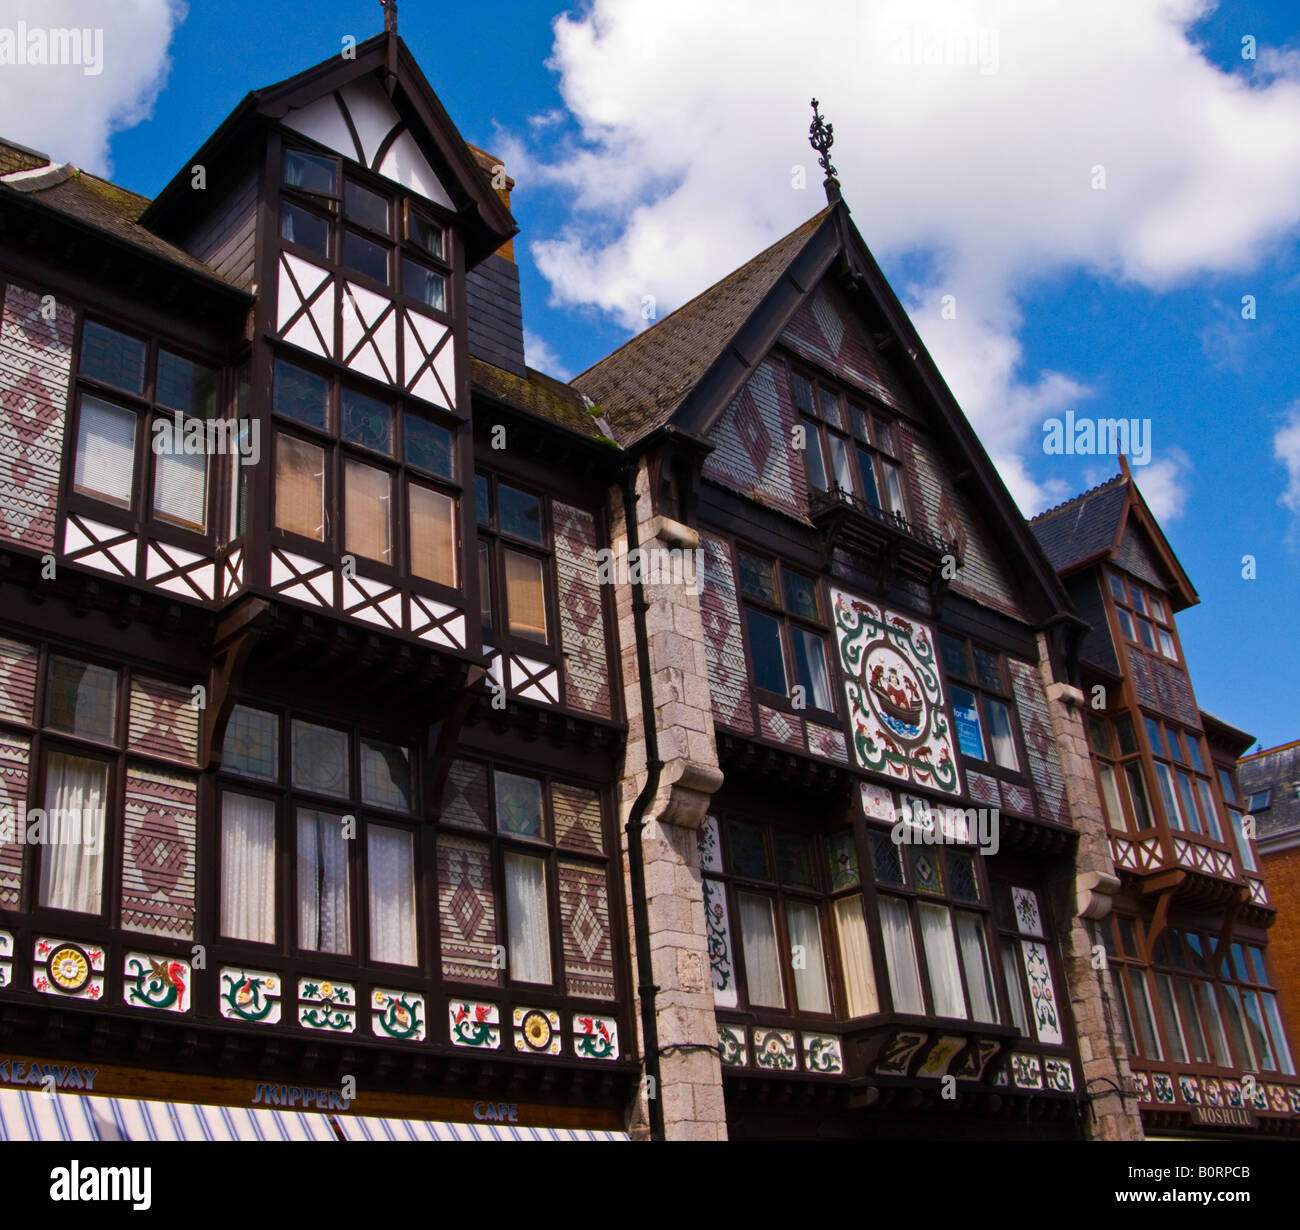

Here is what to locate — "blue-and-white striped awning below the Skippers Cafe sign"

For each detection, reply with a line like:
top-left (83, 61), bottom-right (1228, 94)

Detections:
top-left (0, 1090), bottom-right (628, 1140)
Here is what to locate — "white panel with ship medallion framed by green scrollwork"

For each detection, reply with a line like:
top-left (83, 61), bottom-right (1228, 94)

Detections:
top-left (831, 589), bottom-right (961, 794)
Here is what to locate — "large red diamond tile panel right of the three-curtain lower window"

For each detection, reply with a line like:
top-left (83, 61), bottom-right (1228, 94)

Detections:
top-left (438, 833), bottom-right (501, 986)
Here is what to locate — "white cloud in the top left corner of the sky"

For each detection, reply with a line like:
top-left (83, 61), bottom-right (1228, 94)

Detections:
top-left (0, 0), bottom-right (186, 176)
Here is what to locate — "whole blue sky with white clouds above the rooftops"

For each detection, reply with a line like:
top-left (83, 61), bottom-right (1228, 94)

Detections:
top-left (10, 0), bottom-right (1300, 746)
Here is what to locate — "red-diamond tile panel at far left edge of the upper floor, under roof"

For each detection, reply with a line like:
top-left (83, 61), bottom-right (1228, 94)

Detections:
top-left (0, 285), bottom-right (77, 553)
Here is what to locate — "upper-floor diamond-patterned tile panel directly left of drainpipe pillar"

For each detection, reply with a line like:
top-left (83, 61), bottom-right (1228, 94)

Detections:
top-left (551, 501), bottom-right (612, 718)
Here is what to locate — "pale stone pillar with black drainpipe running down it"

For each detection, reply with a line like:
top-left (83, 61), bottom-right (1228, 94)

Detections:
top-left (610, 463), bottom-right (727, 1140)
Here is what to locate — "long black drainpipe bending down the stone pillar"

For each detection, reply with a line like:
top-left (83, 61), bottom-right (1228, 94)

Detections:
top-left (620, 465), bottom-right (664, 1140)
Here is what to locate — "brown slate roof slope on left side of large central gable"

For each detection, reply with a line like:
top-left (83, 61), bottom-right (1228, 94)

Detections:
top-left (572, 205), bottom-right (832, 447)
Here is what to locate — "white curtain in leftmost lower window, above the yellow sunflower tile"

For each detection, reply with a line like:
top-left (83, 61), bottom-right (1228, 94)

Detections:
top-left (40, 752), bottom-right (108, 914)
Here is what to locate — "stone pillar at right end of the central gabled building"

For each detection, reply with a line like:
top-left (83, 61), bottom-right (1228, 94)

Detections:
top-left (1039, 635), bottom-right (1143, 1140)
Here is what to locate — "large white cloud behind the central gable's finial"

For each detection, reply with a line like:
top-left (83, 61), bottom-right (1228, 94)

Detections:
top-left (511, 0), bottom-right (1300, 512)
